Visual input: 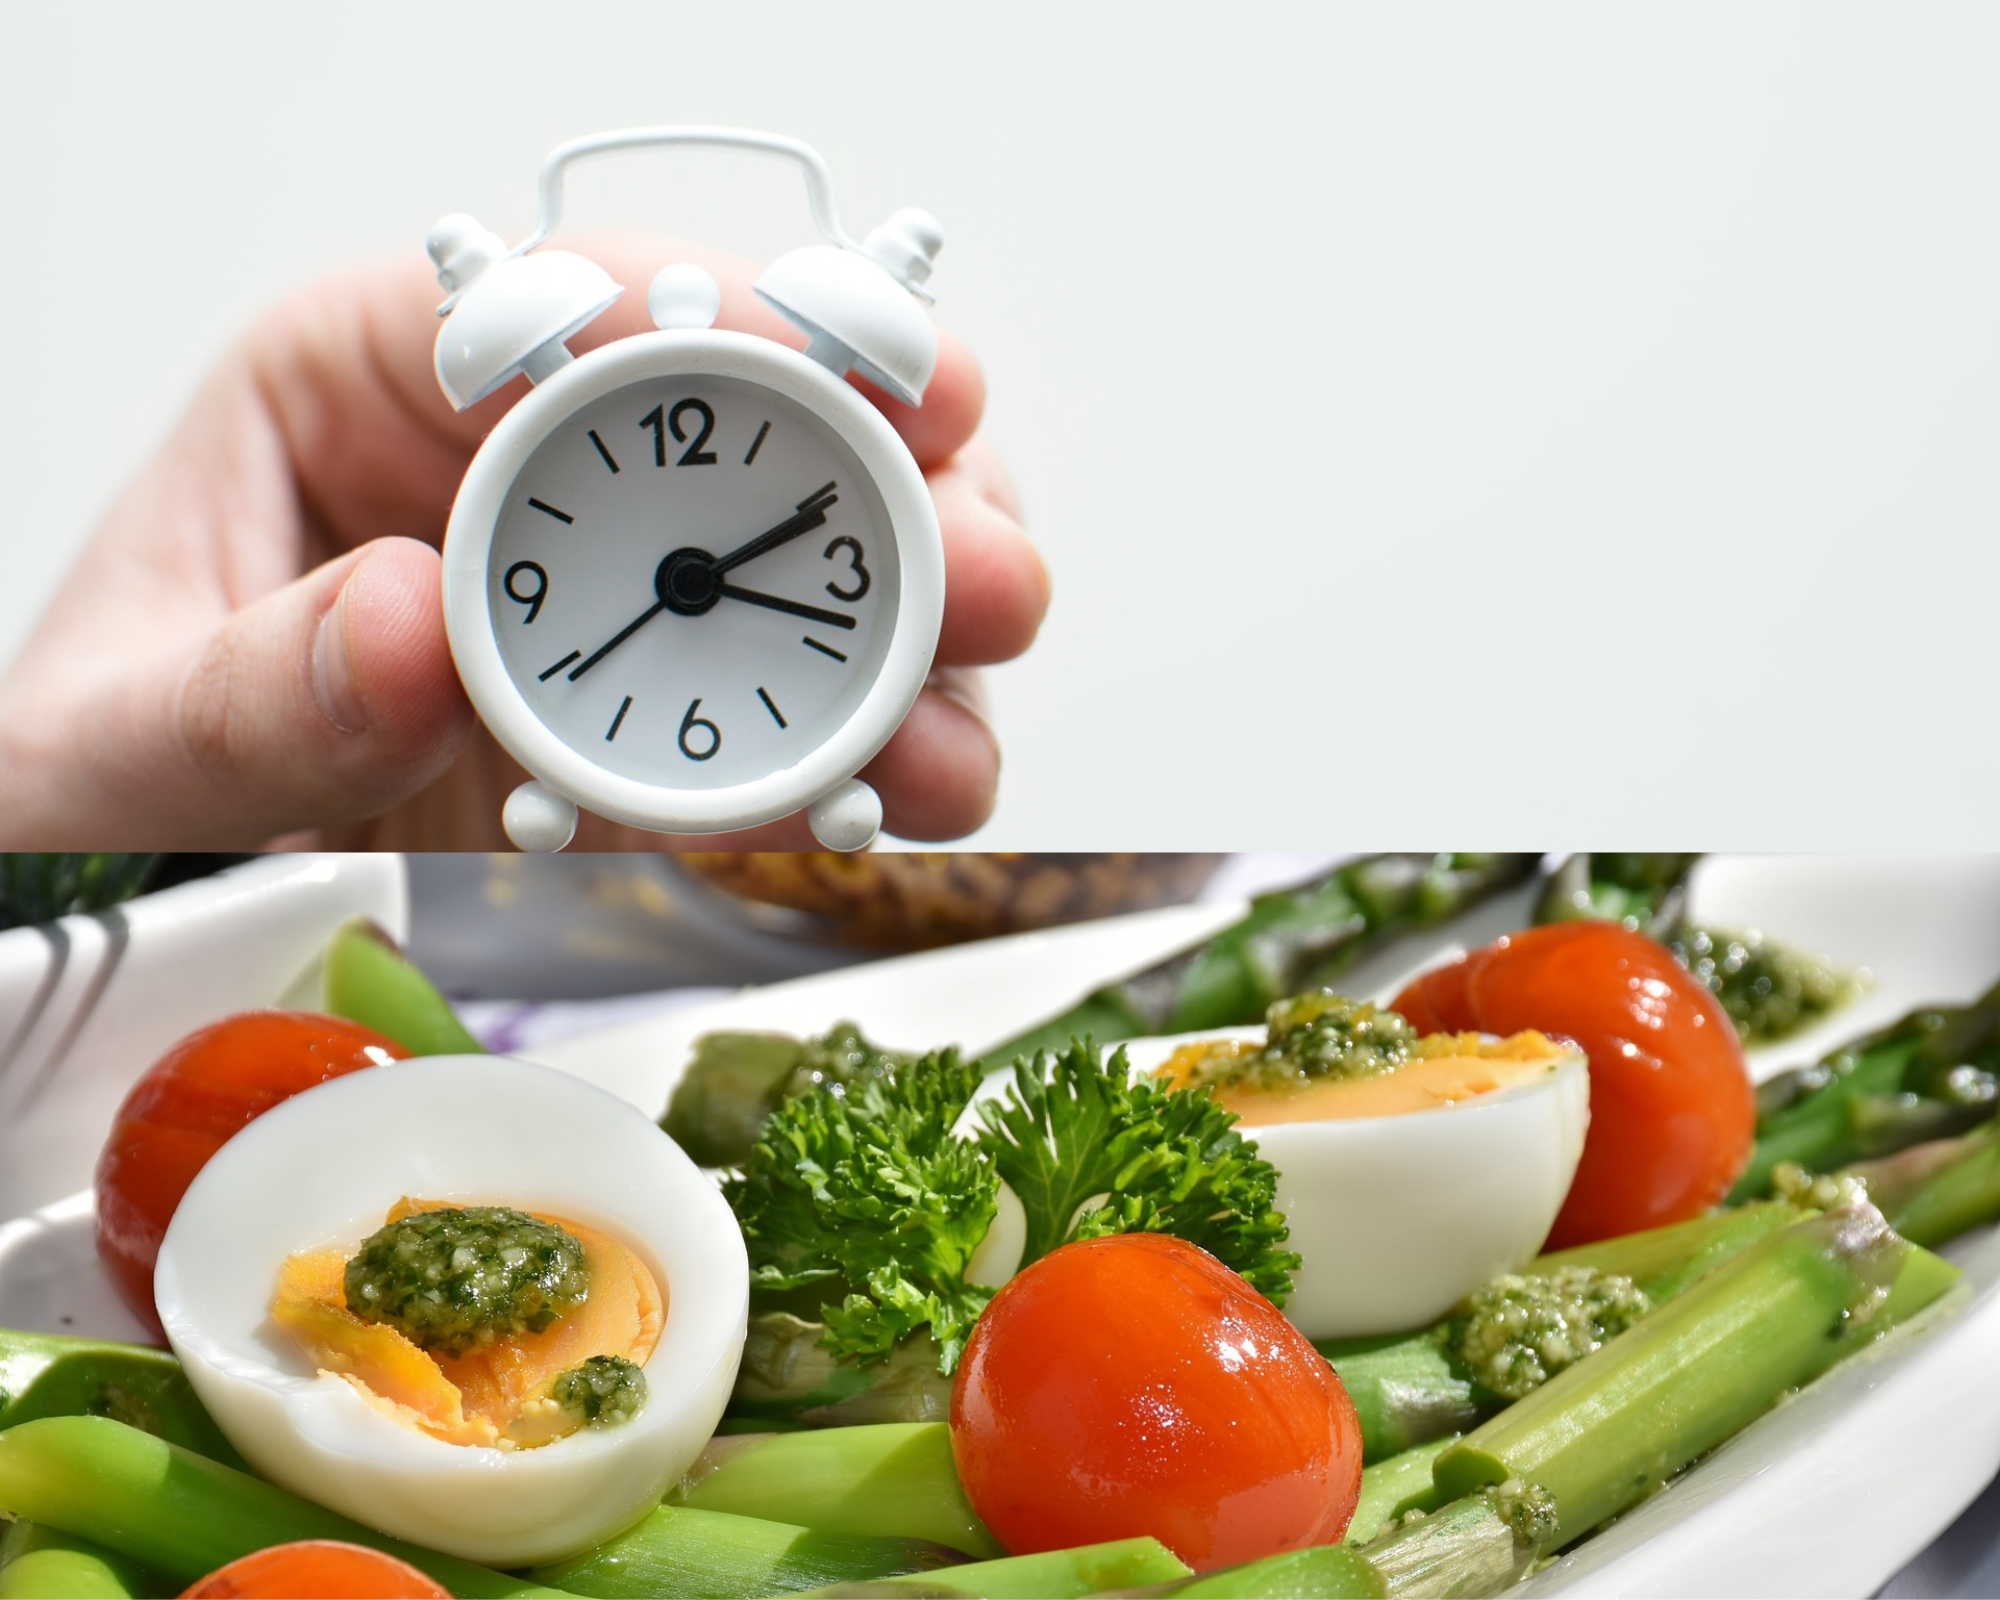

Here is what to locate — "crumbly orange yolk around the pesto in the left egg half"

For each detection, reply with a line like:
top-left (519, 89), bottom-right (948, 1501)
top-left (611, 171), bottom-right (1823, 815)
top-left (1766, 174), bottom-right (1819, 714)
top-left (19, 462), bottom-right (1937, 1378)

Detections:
top-left (270, 1198), bottom-right (666, 1450)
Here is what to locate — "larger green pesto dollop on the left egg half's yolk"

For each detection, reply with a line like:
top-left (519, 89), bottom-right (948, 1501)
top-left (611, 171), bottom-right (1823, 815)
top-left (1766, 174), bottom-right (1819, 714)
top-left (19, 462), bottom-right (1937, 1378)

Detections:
top-left (344, 1206), bottom-right (590, 1356)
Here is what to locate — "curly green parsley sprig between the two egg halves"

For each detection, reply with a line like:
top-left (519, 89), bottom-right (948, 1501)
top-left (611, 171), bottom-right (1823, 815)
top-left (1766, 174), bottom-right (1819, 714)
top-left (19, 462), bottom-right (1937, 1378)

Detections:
top-left (724, 1040), bottom-right (1298, 1384)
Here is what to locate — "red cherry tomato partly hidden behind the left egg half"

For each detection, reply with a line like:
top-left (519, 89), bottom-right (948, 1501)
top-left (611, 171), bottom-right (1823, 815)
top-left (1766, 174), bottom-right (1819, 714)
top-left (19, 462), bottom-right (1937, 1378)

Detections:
top-left (98, 1012), bottom-right (410, 1332)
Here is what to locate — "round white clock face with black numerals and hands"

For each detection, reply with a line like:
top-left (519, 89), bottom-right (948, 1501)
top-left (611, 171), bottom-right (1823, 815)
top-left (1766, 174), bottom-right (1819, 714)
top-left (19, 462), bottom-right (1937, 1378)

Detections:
top-left (486, 374), bottom-right (902, 790)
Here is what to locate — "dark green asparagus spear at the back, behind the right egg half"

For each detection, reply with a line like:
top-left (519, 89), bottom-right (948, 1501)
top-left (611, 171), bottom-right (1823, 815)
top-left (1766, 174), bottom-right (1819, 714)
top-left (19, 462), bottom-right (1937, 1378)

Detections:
top-left (986, 854), bottom-right (1540, 1066)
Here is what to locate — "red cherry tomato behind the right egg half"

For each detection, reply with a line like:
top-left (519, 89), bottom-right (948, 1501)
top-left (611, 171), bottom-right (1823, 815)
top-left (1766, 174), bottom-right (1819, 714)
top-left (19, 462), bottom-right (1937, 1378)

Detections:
top-left (1390, 922), bottom-right (1756, 1250)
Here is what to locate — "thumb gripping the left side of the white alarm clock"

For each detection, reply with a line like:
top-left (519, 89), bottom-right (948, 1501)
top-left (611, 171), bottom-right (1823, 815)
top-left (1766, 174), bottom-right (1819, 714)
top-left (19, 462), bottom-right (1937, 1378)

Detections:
top-left (30, 538), bottom-right (472, 850)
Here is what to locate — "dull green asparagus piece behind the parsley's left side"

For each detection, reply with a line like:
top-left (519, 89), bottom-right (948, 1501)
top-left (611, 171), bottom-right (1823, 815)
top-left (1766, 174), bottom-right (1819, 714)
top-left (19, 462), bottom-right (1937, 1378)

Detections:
top-left (660, 1022), bottom-right (912, 1166)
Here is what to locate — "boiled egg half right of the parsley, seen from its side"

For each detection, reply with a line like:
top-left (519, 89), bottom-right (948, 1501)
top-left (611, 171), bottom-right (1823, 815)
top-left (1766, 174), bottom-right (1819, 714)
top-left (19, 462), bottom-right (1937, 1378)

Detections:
top-left (1126, 1028), bottom-right (1590, 1340)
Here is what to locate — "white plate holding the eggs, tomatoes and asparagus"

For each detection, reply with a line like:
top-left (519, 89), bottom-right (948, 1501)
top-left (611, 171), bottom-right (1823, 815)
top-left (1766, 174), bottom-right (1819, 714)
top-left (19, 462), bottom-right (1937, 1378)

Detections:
top-left (0, 856), bottom-right (2000, 1596)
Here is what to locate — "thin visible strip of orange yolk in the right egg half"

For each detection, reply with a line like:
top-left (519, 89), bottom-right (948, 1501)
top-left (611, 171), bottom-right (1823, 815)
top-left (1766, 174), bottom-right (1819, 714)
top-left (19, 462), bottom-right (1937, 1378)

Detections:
top-left (1154, 1030), bottom-right (1564, 1126)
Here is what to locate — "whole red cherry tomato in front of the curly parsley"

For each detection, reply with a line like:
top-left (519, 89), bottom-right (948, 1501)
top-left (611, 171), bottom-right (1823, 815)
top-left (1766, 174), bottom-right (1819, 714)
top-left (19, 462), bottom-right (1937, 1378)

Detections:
top-left (952, 1234), bottom-right (1362, 1572)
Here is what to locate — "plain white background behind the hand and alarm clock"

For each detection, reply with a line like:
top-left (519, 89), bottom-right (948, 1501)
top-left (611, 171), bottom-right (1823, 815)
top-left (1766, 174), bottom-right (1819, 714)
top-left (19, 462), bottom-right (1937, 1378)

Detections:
top-left (0, 0), bottom-right (2000, 848)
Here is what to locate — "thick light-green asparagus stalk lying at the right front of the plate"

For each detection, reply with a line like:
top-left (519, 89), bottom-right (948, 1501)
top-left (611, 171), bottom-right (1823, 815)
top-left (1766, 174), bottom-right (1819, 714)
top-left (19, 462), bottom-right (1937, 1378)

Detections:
top-left (1432, 1206), bottom-right (1956, 1550)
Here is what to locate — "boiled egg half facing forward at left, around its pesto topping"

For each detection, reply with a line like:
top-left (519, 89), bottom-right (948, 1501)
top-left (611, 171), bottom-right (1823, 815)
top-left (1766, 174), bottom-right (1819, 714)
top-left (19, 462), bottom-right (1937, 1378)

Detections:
top-left (154, 1056), bottom-right (750, 1566)
